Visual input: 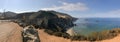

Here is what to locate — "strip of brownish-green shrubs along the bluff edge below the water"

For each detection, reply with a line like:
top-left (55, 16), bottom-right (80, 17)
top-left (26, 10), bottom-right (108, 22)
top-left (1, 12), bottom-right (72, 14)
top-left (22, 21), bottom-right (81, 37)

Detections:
top-left (71, 28), bottom-right (120, 41)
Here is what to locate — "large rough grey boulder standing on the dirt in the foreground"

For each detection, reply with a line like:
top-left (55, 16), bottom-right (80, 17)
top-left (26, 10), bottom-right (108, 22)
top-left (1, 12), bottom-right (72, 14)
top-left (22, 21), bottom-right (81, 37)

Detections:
top-left (22, 25), bottom-right (40, 42)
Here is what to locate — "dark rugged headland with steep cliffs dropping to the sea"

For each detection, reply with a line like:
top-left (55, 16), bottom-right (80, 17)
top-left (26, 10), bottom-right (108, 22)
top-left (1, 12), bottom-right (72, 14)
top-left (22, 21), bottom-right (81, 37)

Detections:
top-left (16, 10), bottom-right (77, 36)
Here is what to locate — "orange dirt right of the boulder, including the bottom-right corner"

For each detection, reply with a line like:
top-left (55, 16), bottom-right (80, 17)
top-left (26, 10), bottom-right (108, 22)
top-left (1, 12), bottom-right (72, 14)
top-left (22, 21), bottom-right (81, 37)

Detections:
top-left (38, 30), bottom-right (120, 42)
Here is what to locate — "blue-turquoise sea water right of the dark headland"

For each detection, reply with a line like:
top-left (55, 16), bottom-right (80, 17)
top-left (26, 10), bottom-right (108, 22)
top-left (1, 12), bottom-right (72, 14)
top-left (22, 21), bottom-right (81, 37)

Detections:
top-left (73, 18), bottom-right (120, 35)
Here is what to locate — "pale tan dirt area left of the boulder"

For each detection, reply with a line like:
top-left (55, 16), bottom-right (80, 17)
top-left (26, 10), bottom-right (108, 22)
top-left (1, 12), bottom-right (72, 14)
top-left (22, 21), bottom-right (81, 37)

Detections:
top-left (0, 22), bottom-right (22, 42)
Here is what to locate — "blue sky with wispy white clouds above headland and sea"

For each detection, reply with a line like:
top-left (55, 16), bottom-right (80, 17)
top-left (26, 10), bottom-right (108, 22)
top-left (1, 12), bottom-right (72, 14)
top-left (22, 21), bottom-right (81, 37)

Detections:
top-left (0, 0), bottom-right (120, 18)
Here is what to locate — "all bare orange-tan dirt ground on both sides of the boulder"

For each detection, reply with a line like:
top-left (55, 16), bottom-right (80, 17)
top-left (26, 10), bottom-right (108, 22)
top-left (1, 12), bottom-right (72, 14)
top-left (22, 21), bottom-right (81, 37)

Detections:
top-left (0, 22), bottom-right (120, 42)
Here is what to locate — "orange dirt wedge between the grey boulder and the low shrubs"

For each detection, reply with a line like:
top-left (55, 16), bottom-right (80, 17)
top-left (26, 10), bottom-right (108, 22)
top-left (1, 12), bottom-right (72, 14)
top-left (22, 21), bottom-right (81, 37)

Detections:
top-left (38, 30), bottom-right (71, 42)
